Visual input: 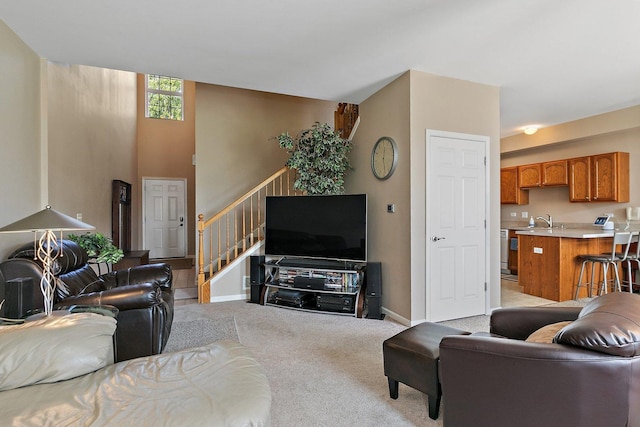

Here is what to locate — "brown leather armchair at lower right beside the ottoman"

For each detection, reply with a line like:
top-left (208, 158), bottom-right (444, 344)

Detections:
top-left (440, 292), bottom-right (640, 427)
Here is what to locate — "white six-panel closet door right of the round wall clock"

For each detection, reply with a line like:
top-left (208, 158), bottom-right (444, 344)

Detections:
top-left (426, 130), bottom-right (489, 322)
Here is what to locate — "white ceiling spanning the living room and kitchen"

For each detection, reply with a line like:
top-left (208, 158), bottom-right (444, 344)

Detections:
top-left (0, 0), bottom-right (640, 136)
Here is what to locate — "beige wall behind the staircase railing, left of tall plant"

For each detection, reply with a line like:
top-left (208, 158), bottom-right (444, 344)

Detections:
top-left (195, 83), bottom-right (337, 301)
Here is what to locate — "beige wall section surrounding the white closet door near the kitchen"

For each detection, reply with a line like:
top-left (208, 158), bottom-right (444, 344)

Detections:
top-left (411, 71), bottom-right (500, 320)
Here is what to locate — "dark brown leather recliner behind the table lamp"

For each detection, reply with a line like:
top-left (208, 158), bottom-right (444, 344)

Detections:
top-left (0, 240), bottom-right (173, 361)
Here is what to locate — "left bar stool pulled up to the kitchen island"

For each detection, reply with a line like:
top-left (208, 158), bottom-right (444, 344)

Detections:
top-left (573, 231), bottom-right (635, 299)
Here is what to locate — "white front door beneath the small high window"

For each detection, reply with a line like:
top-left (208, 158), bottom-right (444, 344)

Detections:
top-left (143, 178), bottom-right (187, 258)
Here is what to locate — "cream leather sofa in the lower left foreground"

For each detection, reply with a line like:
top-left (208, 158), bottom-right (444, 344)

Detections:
top-left (0, 313), bottom-right (271, 426)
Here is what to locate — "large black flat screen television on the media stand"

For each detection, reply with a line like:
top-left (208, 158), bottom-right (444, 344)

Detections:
top-left (265, 194), bottom-right (367, 262)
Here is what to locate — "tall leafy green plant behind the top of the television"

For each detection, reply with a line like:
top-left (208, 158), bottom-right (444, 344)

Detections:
top-left (276, 122), bottom-right (352, 195)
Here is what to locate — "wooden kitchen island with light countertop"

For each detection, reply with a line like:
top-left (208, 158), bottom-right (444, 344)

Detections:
top-left (516, 227), bottom-right (614, 301)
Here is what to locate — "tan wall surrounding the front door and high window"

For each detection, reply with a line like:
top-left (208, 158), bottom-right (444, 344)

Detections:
top-left (133, 74), bottom-right (197, 255)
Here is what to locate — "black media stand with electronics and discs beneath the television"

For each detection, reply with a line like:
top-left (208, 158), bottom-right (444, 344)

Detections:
top-left (262, 261), bottom-right (364, 317)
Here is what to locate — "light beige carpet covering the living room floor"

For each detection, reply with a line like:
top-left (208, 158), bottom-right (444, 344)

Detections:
top-left (175, 301), bottom-right (592, 427)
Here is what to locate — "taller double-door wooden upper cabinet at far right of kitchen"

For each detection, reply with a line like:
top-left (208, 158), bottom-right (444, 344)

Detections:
top-left (569, 152), bottom-right (629, 203)
